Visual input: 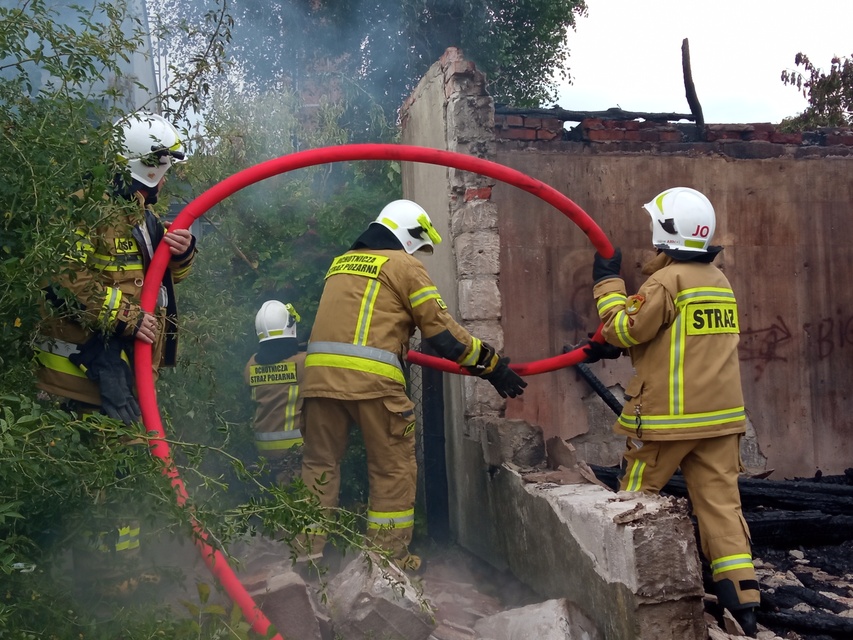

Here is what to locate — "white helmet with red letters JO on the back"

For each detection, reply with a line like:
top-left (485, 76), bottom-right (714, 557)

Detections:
top-left (643, 187), bottom-right (717, 253)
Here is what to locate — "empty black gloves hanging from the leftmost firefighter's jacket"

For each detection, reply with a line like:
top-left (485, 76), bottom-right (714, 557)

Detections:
top-left (68, 334), bottom-right (141, 425)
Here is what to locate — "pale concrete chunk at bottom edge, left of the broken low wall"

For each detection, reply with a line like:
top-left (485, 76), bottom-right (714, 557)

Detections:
top-left (474, 599), bottom-right (604, 640)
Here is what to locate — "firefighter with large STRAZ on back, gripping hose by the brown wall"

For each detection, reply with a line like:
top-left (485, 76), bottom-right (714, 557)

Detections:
top-left (587, 187), bottom-right (759, 636)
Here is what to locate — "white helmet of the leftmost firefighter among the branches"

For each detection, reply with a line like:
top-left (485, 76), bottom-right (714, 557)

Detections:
top-left (116, 111), bottom-right (184, 187)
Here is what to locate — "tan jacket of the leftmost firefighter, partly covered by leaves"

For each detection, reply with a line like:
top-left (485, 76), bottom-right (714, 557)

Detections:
top-left (36, 192), bottom-right (195, 406)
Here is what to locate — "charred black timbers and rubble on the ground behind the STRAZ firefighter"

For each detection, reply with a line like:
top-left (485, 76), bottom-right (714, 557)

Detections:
top-left (592, 466), bottom-right (853, 640)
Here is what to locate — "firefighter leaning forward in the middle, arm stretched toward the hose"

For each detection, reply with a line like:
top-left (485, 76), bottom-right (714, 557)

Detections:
top-left (302, 200), bottom-right (527, 571)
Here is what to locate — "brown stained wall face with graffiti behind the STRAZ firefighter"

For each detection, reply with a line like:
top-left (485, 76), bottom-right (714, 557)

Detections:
top-left (493, 126), bottom-right (853, 479)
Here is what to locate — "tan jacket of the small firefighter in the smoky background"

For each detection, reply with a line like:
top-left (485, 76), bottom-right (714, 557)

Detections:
top-left (245, 353), bottom-right (305, 458)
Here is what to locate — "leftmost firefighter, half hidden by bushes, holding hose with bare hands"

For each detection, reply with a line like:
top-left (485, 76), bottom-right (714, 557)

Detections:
top-left (35, 113), bottom-right (195, 594)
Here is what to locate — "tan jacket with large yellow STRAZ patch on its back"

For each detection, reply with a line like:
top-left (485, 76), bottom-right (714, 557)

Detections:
top-left (593, 253), bottom-right (746, 440)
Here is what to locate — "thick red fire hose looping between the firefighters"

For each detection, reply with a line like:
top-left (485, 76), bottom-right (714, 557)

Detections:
top-left (134, 144), bottom-right (613, 640)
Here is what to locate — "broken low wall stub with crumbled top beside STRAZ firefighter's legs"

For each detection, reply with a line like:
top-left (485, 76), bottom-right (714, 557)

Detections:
top-left (484, 465), bottom-right (707, 640)
